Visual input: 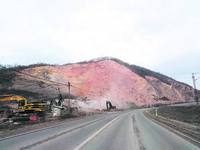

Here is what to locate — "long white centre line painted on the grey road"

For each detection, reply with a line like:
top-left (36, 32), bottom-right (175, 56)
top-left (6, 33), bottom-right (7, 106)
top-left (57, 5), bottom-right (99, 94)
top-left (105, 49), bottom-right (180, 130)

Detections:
top-left (74, 114), bottom-right (123, 150)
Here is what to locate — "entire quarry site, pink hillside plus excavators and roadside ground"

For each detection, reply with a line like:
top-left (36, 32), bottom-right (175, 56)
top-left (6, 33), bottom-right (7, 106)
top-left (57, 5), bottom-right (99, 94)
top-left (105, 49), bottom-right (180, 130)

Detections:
top-left (0, 59), bottom-right (197, 143)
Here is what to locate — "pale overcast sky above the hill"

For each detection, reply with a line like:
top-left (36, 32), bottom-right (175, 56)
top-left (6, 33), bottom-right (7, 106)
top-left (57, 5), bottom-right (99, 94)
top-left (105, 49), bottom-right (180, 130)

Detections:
top-left (0, 0), bottom-right (200, 89)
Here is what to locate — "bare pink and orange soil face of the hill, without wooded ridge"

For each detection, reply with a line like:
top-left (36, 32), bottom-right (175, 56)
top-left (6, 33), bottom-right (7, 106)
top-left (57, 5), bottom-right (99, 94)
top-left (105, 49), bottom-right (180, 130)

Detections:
top-left (12, 60), bottom-right (193, 108)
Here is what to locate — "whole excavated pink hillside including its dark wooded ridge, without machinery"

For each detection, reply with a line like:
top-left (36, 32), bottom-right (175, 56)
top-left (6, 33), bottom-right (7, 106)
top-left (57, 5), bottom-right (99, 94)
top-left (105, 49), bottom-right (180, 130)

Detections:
top-left (0, 59), bottom-right (194, 108)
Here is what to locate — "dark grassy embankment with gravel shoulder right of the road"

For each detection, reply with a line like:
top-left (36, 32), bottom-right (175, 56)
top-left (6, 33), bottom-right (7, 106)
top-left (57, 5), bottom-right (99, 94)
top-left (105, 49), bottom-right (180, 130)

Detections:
top-left (144, 106), bottom-right (200, 147)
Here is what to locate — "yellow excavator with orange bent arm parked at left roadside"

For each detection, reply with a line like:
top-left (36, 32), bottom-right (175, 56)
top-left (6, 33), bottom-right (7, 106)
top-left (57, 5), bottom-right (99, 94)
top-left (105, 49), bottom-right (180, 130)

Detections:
top-left (0, 94), bottom-right (50, 120)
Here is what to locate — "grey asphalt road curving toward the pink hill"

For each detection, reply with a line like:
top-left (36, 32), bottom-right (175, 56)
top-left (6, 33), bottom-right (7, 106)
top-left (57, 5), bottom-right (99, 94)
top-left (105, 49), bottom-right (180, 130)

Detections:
top-left (0, 110), bottom-right (200, 150)
